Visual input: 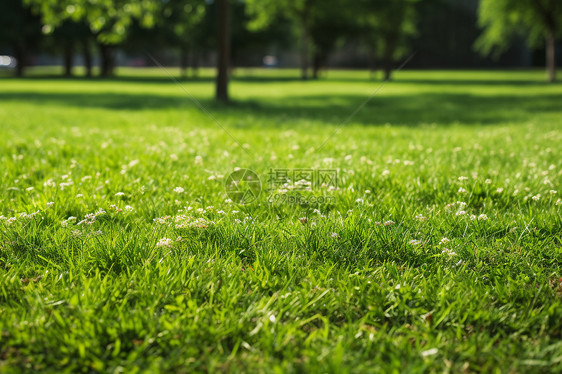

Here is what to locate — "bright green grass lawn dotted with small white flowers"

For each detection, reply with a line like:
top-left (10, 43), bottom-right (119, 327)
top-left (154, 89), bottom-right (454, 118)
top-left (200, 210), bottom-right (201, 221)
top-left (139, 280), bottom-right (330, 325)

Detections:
top-left (0, 69), bottom-right (562, 373)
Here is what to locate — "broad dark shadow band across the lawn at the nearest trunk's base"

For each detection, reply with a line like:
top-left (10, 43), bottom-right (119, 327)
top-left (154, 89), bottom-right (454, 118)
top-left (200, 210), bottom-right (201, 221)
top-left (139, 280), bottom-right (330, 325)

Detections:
top-left (0, 92), bottom-right (562, 127)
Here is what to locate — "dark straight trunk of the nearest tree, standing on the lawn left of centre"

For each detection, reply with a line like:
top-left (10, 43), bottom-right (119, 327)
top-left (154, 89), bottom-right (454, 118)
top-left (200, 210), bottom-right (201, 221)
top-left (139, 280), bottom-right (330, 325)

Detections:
top-left (216, 0), bottom-right (230, 103)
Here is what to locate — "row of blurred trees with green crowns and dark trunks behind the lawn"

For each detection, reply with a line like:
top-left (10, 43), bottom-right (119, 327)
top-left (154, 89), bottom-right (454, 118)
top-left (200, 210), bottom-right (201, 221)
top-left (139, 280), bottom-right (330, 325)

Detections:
top-left (0, 0), bottom-right (562, 101)
